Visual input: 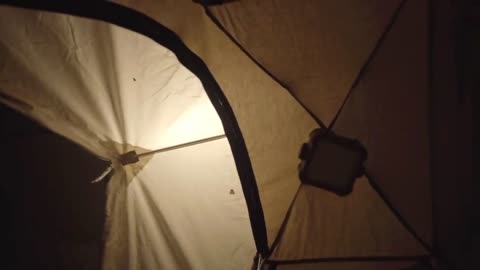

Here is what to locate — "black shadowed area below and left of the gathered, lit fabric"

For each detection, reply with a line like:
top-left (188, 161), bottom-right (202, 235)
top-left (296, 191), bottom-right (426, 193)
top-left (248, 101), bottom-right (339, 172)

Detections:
top-left (0, 105), bottom-right (106, 270)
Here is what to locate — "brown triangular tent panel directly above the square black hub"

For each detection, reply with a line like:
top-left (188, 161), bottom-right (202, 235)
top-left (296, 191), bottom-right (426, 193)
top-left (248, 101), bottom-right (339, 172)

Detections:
top-left (209, 0), bottom-right (401, 125)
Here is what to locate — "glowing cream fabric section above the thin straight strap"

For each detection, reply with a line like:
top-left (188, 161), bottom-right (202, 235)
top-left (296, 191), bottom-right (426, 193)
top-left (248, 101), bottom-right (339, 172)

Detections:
top-left (2, 5), bottom-right (223, 152)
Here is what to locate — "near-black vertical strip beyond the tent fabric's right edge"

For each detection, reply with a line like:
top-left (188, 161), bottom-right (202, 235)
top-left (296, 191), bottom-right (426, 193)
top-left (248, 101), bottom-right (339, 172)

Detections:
top-left (432, 1), bottom-right (480, 269)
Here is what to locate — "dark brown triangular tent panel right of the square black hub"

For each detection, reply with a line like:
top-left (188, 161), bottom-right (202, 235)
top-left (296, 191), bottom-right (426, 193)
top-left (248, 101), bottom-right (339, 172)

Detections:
top-left (334, 0), bottom-right (432, 245)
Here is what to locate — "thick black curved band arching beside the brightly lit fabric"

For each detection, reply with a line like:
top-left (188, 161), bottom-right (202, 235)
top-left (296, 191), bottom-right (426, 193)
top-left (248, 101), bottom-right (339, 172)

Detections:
top-left (0, 0), bottom-right (268, 257)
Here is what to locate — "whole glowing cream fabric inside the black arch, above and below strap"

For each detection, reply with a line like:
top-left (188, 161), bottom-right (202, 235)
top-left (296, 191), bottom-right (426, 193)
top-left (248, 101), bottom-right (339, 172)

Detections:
top-left (0, 7), bottom-right (255, 269)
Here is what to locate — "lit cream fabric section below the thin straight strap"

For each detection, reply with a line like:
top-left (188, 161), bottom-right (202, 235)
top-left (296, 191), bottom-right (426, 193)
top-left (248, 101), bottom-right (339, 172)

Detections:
top-left (126, 138), bottom-right (255, 270)
